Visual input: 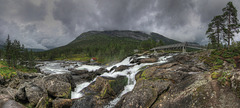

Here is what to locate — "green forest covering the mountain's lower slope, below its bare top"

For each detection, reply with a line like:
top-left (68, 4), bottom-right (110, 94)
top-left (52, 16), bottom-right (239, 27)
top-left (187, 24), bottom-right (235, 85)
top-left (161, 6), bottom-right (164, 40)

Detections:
top-left (36, 36), bottom-right (164, 63)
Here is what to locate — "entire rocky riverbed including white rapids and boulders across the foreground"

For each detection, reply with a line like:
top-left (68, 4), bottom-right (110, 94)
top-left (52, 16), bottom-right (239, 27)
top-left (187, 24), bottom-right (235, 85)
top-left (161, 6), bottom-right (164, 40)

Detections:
top-left (0, 52), bottom-right (240, 108)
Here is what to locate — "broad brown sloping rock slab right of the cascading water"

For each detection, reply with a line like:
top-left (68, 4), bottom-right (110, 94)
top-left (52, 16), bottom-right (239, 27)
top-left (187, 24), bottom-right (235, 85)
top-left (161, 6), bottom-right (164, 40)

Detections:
top-left (115, 53), bottom-right (240, 108)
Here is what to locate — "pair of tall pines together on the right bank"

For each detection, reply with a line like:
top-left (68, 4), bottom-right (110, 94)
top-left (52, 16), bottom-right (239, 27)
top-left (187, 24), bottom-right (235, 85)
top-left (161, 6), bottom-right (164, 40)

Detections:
top-left (206, 2), bottom-right (240, 48)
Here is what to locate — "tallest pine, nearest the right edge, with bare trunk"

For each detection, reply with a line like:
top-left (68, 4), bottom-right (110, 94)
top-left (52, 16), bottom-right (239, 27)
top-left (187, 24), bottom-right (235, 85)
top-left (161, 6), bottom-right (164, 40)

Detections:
top-left (222, 2), bottom-right (240, 47)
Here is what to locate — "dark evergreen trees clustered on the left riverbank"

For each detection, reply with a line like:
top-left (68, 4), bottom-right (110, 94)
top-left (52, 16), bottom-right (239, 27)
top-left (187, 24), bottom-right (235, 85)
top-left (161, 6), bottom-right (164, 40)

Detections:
top-left (0, 35), bottom-right (35, 68)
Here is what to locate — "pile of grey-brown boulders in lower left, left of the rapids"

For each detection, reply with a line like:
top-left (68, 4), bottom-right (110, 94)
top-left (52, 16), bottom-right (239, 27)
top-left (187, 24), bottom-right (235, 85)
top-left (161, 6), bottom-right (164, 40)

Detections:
top-left (0, 72), bottom-right (75, 108)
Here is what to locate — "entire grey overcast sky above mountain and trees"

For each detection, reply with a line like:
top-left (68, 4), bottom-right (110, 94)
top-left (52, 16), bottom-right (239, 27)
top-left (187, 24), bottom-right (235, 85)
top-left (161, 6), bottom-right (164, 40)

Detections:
top-left (0, 0), bottom-right (240, 49)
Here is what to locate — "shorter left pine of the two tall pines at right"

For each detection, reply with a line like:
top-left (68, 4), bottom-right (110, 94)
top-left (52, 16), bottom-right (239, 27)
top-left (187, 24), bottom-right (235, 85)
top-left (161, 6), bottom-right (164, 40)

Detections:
top-left (206, 15), bottom-right (225, 47)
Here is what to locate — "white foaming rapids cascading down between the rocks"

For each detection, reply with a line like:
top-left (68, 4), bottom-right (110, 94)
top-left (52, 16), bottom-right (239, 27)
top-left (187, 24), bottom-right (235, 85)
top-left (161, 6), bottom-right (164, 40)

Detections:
top-left (39, 56), bottom-right (172, 108)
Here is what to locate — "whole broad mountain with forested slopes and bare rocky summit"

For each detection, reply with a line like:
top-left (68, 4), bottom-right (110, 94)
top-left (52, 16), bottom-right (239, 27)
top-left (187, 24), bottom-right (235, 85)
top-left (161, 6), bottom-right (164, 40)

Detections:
top-left (38, 30), bottom-right (179, 62)
